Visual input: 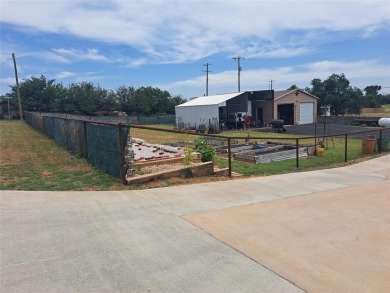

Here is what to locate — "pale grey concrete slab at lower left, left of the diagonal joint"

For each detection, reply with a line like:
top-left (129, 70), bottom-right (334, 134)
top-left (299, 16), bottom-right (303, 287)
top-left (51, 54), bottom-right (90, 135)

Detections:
top-left (0, 191), bottom-right (303, 293)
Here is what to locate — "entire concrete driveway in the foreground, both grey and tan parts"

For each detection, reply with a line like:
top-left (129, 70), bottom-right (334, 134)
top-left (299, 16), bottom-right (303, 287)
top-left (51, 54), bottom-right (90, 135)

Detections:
top-left (0, 155), bottom-right (390, 292)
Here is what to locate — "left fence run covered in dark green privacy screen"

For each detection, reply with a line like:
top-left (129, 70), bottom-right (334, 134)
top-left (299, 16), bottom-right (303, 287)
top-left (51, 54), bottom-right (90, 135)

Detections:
top-left (24, 112), bottom-right (130, 182)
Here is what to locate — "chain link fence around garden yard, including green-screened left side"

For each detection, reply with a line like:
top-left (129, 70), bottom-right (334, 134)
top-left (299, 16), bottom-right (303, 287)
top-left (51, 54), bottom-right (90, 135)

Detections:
top-left (25, 112), bottom-right (390, 183)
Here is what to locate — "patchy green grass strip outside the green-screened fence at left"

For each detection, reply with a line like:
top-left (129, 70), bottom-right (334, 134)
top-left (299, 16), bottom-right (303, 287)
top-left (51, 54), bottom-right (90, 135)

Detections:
top-left (0, 120), bottom-right (123, 190)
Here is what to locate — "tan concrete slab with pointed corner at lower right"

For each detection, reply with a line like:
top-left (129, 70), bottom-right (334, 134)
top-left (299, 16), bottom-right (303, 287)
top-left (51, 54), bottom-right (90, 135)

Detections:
top-left (185, 180), bottom-right (390, 293)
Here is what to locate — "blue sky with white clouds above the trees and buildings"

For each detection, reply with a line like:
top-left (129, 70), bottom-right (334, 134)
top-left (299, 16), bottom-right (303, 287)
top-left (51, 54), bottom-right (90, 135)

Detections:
top-left (0, 0), bottom-right (390, 99)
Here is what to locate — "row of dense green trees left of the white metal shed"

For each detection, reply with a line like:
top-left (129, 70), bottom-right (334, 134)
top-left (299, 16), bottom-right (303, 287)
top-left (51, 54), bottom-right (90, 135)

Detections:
top-left (3, 75), bottom-right (185, 116)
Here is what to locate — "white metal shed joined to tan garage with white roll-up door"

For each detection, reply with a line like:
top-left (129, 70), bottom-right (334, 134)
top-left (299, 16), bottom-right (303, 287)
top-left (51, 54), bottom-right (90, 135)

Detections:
top-left (175, 89), bottom-right (318, 132)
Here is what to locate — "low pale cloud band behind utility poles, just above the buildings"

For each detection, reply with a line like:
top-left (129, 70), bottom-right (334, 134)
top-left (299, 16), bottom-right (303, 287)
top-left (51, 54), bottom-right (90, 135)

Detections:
top-left (163, 60), bottom-right (390, 98)
